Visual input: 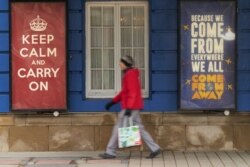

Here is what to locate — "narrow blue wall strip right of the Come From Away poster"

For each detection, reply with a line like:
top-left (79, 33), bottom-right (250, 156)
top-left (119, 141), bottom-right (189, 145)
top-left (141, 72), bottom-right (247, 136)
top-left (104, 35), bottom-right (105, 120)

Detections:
top-left (237, 0), bottom-right (250, 111)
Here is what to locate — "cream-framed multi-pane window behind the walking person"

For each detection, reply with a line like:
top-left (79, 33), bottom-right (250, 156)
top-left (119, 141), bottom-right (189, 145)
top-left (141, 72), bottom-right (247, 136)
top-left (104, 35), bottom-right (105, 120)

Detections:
top-left (86, 1), bottom-right (148, 98)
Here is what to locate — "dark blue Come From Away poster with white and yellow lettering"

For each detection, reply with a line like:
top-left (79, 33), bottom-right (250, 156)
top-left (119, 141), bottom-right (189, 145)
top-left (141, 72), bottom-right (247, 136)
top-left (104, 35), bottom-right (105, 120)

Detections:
top-left (180, 1), bottom-right (236, 110)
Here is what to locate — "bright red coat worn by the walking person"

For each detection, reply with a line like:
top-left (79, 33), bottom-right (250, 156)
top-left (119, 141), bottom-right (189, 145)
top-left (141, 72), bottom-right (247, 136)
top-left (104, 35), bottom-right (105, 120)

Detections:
top-left (112, 68), bottom-right (143, 110)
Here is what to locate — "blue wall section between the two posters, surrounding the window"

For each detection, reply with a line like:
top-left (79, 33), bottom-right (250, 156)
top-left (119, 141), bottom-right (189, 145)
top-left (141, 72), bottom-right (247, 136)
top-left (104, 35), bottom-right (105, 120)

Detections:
top-left (69, 0), bottom-right (178, 112)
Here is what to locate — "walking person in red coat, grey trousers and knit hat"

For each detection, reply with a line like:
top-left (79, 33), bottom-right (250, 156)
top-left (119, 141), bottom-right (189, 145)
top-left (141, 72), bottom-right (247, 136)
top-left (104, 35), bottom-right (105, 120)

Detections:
top-left (100, 56), bottom-right (161, 159)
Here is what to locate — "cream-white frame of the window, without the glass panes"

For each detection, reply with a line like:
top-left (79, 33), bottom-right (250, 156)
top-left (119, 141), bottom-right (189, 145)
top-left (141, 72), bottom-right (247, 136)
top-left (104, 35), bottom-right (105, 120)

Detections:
top-left (85, 1), bottom-right (149, 98)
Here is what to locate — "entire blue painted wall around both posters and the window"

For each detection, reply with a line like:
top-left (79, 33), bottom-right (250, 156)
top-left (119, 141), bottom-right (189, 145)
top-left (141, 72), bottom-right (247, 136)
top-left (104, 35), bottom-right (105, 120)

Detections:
top-left (0, 0), bottom-right (250, 112)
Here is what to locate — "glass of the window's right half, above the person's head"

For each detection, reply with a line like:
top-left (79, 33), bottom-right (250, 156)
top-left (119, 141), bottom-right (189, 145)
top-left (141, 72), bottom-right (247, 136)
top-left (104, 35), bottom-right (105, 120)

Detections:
top-left (120, 6), bottom-right (146, 89)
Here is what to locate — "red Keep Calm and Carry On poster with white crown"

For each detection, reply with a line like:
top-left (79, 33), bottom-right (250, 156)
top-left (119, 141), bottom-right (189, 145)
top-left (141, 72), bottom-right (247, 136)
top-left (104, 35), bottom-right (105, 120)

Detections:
top-left (11, 2), bottom-right (67, 110)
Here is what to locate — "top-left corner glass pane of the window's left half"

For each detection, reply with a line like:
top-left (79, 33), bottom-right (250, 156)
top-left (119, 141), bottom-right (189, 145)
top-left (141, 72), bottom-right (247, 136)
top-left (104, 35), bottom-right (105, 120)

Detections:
top-left (90, 7), bottom-right (102, 26)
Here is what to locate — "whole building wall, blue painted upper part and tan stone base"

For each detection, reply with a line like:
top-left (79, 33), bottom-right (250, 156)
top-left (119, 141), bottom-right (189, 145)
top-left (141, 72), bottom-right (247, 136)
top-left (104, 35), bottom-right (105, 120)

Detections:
top-left (0, 0), bottom-right (250, 152)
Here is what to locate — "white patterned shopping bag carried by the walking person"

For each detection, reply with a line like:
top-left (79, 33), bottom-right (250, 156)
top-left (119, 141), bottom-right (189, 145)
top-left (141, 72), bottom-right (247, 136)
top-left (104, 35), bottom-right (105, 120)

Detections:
top-left (118, 117), bottom-right (142, 148)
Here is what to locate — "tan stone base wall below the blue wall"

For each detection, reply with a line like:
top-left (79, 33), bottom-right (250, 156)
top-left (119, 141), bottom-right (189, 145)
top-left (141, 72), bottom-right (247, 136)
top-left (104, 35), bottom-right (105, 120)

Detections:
top-left (0, 113), bottom-right (250, 152)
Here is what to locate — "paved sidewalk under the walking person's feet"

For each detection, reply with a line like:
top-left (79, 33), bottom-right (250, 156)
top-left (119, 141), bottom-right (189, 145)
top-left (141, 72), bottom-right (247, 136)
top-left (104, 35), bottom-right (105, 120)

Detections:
top-left (0, 151), bottom-right (250, 167)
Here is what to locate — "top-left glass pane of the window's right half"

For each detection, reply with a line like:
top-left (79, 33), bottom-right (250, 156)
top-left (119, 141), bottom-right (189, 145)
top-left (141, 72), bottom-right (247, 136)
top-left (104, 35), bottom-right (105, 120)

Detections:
top-left (120, 7), bottom-right (132, 26)
